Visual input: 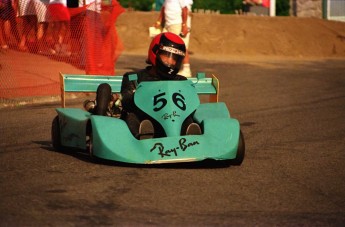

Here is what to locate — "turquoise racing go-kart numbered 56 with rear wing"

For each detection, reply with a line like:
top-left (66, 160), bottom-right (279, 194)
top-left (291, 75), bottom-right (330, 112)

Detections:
top-left (51, 73), bottom-right (245, 165)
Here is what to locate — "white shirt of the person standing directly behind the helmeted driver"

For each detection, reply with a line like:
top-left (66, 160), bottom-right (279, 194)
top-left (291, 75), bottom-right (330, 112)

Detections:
top-left (163, 0), bottom-right (189, 26)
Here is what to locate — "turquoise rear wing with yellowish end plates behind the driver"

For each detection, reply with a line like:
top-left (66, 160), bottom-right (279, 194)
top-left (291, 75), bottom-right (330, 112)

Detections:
top-left (60, 73), bottom-right (219, 108)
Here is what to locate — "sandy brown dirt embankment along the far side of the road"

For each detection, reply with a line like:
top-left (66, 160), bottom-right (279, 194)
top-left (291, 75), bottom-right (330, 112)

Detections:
top-left (117, 12), bottom-right (345, 58)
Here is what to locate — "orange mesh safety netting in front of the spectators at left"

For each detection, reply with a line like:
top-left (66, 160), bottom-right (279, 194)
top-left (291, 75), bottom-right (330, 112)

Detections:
top-left (0, 1), bottom-right (125, 101)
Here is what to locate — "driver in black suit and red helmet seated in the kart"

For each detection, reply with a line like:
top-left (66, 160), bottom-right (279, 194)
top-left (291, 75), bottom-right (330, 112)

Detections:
top-left (87, 32), bottom-right (201, 139)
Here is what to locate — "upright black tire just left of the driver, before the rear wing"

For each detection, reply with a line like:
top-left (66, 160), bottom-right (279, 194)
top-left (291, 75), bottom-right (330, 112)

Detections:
top-left (94, 83), bottom-right (111, 116)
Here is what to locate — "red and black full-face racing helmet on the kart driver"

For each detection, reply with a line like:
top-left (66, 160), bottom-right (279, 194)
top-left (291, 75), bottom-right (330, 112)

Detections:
top-left (147, 32), bottom-right (186, 79)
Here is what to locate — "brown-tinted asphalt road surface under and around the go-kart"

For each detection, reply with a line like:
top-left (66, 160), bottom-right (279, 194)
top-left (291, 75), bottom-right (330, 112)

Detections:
top-left (0, 56), bottom-right (345, 226)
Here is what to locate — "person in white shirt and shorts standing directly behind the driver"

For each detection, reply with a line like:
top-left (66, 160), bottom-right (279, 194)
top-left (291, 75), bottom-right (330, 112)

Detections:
top-left (154, 0), bottom-right (193, 77)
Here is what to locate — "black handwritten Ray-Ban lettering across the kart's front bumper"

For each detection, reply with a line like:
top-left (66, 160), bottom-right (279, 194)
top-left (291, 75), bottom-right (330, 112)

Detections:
top-left (150, 138), bottom-right (200, 158)
